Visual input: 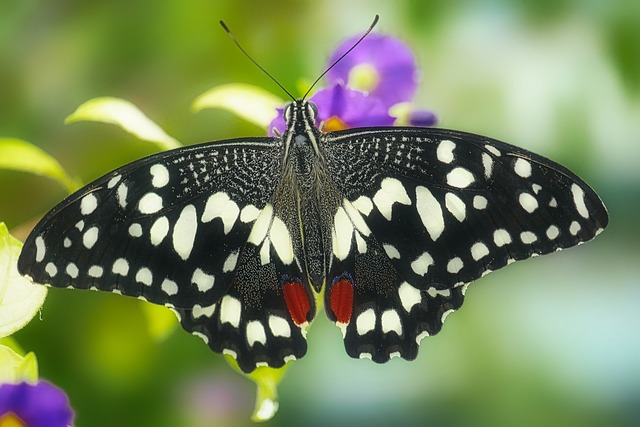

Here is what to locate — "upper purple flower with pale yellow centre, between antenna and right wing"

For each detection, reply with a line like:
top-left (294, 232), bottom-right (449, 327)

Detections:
top-left (327, 33), bottom-right (418, 107)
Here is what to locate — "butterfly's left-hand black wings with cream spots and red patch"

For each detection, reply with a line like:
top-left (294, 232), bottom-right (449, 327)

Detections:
top-left (18, 138), bottom-right (315, 371)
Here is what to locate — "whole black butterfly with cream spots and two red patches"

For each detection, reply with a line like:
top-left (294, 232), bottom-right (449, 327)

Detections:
top-left (13, 19), bottom-right (608, 372)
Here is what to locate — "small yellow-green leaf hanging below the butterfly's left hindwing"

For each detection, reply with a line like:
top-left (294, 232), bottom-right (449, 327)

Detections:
top-left (224, 354), bottom-right (291, 422)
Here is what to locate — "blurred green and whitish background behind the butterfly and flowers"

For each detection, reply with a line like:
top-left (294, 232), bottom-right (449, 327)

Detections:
top-left (0, 0), bottom-right (640, 427)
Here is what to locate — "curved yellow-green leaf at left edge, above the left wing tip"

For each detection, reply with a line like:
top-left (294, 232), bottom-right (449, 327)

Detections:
top-left (0, 138), bottom-right (80, 193)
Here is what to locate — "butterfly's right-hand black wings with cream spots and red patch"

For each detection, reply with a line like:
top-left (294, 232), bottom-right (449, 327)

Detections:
top-left (323, 128), bottom-right (608, 362)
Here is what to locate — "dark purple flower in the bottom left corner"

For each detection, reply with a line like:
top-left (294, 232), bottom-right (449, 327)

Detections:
top-left (0, 381), bottom-right (73, 427)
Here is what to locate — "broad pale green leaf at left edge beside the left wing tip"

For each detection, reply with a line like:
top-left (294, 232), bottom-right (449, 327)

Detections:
top-left (0, 222), bottom-right (47, 337)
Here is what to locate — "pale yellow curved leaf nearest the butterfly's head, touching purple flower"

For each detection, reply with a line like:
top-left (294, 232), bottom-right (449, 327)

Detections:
top-left (193, 83), bottom-right (285, 129)
